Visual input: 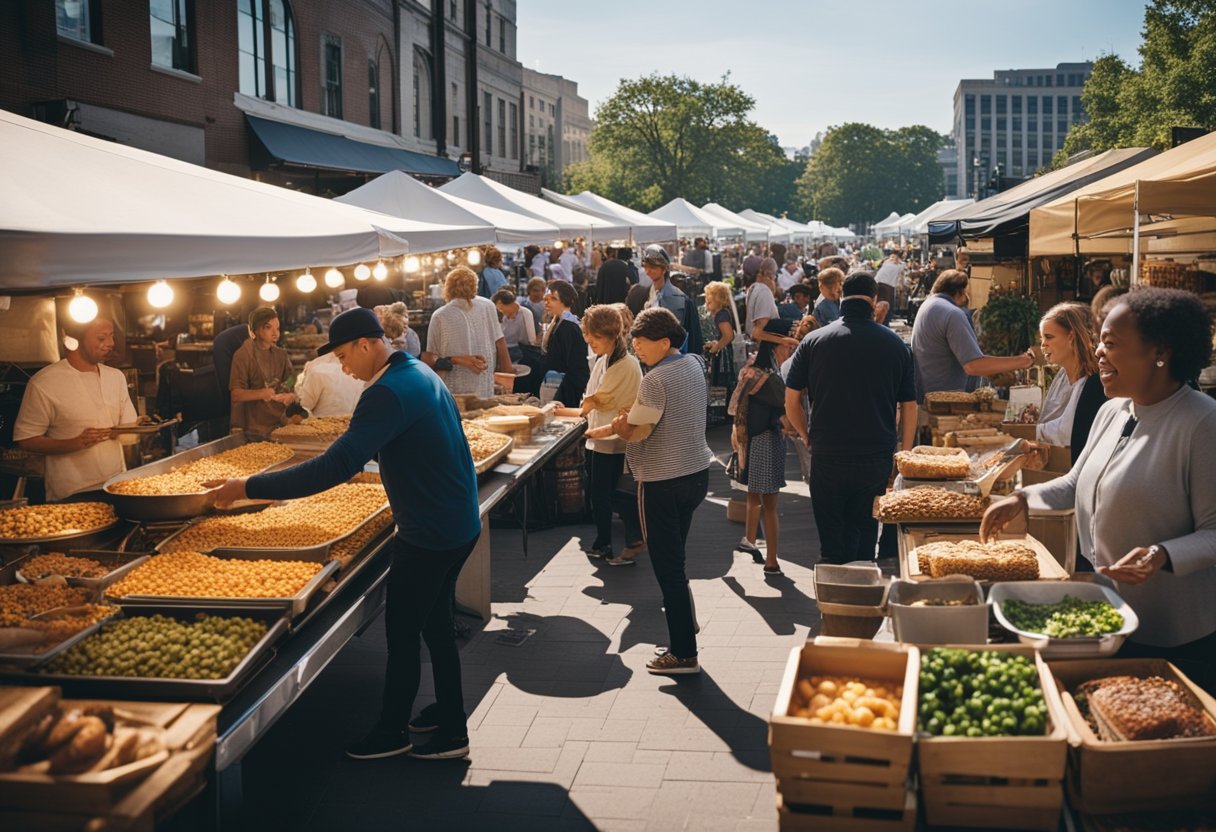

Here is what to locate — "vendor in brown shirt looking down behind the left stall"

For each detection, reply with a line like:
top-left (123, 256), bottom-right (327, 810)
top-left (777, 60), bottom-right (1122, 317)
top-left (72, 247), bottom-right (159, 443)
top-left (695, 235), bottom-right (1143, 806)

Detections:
top-left (229, 307), bottom-right (295, 437)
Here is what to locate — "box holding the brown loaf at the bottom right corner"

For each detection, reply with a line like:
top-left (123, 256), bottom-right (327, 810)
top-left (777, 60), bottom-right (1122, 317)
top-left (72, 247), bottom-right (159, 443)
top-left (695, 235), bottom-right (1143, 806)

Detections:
top-left (1047, 658), bottom-right (1216, 814)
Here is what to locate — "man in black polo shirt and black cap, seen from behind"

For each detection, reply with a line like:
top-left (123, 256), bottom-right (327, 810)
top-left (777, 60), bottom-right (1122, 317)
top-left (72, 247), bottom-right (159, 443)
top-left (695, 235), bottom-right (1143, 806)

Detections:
top-left (786, 271), bottom-right (916, 563)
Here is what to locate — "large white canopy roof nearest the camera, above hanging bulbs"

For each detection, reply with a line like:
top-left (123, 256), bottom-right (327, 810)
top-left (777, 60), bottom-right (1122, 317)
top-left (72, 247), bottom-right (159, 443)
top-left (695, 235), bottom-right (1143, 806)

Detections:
top-left (0, 111), bottom-right (494, 288)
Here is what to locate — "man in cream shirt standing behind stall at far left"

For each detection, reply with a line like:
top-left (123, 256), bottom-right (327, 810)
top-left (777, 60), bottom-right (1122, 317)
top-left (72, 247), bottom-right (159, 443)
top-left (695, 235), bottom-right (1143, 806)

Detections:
top-left (12, 317), bottom-right (136, 502)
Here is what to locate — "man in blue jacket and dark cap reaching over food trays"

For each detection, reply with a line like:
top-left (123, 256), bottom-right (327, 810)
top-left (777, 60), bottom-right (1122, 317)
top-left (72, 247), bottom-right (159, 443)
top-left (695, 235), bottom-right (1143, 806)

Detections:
top-left (209, 308), bottom-right (482, 759)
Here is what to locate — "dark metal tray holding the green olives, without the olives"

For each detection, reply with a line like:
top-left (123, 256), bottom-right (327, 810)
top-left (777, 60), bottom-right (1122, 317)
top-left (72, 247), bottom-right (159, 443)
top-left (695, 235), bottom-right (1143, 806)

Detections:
top-left (23, 606), bottom-right (288, 702)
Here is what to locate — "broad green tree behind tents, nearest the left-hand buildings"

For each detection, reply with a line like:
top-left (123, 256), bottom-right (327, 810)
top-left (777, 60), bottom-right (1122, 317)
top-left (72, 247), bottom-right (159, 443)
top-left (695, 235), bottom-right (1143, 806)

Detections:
top-left (565, 74), bottom-right (796, 210)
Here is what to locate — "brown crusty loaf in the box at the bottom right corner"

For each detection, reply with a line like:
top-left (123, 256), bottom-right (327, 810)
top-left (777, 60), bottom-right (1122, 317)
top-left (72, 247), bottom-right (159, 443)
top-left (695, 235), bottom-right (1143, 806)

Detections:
top-left (1077, 676), bottom-right (1216, 741)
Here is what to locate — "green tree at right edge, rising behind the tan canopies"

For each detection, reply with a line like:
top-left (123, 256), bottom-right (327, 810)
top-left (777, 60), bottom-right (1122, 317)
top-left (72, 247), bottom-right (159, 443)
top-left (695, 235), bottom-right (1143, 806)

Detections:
top-left (1053, 0), bottom-right (1216, 167)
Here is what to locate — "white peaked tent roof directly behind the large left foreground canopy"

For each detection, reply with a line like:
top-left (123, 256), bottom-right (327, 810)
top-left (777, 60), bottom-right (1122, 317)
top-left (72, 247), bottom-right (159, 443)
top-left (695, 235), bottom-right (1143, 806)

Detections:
top-left (336, 170), bottom-right (558, 244)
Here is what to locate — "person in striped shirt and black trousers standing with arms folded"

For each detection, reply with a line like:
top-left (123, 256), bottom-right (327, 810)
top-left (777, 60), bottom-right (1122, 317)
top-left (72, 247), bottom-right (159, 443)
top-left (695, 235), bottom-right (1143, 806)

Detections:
top-left (587, 308), bottom-right (714, 675)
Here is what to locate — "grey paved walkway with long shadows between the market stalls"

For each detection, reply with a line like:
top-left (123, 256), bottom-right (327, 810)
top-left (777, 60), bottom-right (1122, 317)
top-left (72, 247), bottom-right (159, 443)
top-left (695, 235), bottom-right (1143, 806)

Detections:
top-left (237, 428), bottom-right (846, 832)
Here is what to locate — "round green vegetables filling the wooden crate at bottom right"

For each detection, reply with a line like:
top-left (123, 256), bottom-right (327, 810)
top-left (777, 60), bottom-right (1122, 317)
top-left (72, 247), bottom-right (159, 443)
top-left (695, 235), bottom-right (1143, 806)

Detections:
top-left (918, 647), bottom-right (1047, 737)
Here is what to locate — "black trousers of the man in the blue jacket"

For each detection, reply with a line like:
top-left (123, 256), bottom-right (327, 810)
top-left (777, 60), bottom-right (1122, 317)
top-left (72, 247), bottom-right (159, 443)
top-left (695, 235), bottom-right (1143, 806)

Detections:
top-left (381, 538), bottom-right (477, 736)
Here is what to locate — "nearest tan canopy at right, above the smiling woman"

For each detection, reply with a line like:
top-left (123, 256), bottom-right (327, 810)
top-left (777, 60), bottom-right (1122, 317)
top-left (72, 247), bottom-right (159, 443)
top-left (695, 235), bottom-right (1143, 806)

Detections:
top-left (1030, 133), bottom-right (1216, 257)
